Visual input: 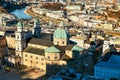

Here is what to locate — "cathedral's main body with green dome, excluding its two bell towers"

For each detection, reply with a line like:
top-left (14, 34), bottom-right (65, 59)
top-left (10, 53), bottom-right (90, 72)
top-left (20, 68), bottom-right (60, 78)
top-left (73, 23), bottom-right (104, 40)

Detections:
top-left (22, 22), bottom-right (83, 74)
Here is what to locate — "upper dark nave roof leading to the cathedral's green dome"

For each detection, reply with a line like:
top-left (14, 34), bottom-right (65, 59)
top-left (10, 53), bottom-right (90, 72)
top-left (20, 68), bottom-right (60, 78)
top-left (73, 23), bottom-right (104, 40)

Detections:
top-left (28, 38), bottom-right (53, 47)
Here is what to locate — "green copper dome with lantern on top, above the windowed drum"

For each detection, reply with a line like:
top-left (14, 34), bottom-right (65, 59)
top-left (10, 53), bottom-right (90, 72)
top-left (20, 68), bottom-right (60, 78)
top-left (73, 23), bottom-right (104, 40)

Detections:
top-left (53, 22), bottom-right (69, 39)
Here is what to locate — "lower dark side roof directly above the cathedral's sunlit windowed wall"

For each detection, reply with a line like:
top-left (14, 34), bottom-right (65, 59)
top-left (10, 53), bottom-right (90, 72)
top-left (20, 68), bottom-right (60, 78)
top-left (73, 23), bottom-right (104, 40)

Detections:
top-left (23, 47), bottom-right (45, 56)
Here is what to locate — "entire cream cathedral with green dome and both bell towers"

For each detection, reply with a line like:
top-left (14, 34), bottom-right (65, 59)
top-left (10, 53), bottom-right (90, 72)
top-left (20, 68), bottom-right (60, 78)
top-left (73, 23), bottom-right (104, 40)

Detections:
top-left (5, 19), bottom-right (84, 73)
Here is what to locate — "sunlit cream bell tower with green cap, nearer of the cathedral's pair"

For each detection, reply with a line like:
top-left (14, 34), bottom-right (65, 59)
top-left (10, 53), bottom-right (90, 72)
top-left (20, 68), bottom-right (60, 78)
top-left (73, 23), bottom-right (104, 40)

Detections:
top-left (15, 21), bottom-right (26, 64)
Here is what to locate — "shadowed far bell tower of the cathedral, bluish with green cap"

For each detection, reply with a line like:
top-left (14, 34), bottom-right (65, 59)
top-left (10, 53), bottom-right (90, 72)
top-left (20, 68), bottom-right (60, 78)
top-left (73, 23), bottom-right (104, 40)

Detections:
top-left (33, 18), bottom-right (41, 38)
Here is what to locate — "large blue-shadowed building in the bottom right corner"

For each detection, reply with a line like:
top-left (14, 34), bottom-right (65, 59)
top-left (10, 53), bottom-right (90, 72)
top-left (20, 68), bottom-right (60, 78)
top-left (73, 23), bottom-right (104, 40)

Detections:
top-left (94, 55), bottom-right (120, 80)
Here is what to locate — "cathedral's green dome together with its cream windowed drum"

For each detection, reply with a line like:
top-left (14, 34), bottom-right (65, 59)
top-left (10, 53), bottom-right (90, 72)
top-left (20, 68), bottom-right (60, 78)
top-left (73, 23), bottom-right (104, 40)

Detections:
top-left (53, 21), bottom-right (69, 46)
